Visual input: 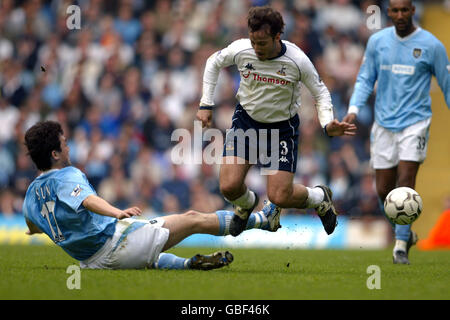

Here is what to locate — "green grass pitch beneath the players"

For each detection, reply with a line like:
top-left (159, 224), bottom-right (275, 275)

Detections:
top-left (0, 245), bottom-right (450, 300)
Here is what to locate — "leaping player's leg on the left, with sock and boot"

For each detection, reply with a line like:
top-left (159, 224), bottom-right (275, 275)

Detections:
top-left (219, 156), bottom-right (259, 236)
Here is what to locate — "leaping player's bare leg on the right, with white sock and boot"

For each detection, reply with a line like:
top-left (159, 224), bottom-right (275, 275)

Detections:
top-left (267, 170), bottom-right (337, 234)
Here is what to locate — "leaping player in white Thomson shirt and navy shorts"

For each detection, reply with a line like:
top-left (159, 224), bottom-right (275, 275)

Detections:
top-left (197, 6), bottom-right (356, 236)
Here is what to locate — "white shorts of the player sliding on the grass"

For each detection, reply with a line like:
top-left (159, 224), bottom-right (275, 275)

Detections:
top-left (80, 218), bottom-right (169, 269)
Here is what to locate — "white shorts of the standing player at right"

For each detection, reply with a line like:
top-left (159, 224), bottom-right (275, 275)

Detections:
top-left (370, 118), bottom-right (431, 169)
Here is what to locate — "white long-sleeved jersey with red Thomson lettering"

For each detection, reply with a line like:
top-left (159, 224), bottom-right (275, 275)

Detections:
top-left (200, 39), bottom-right (334, 127)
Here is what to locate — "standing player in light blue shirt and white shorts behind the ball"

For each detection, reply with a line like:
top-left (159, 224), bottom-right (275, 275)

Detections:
top-left (344, 0), bottom-right (450, 264)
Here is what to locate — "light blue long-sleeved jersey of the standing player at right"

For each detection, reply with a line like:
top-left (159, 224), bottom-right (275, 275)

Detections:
top-left (349, 27), bottom-right (450, 132)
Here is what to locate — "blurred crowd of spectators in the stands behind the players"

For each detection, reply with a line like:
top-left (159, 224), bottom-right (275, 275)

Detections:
top-left (0, 0), bottom-right (422, 217)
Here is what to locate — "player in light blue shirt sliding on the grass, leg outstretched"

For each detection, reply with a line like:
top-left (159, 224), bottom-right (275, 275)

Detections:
top-left (23, 121), bottom-right (281, 270)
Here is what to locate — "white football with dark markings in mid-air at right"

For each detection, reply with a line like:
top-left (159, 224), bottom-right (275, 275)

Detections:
top-left (384, 187), bottom-right (423, 225)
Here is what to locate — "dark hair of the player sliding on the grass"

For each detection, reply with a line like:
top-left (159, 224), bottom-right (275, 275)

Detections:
top-left (25, 121), bottom-right (64, 171)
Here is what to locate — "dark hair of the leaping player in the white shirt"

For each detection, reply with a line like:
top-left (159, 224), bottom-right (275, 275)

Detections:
top-left (247, 6), bottom-right (284, 38)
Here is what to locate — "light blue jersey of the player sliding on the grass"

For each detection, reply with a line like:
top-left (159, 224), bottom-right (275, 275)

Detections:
top-left (23, 167), bottom-right (117, 261)
